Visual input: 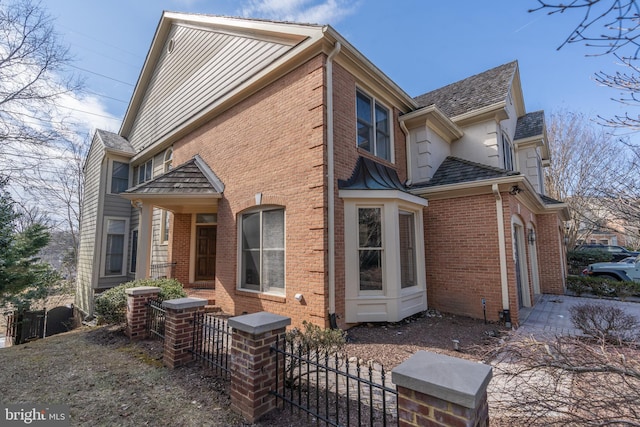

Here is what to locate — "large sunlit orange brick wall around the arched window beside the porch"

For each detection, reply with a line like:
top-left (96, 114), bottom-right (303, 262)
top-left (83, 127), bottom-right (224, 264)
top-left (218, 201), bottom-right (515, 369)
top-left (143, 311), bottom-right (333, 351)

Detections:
top-left (173, 56), bottom-right (327, 326)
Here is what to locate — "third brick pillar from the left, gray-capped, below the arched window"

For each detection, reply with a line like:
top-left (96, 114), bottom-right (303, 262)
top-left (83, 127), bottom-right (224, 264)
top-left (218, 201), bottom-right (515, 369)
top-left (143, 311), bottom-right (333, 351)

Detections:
top-left (229, 311), bottom-right (291, 423)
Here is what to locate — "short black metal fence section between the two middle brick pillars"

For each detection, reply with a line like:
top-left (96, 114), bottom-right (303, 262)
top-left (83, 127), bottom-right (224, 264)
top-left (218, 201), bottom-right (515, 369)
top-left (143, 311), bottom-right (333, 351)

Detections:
top-left (191, 313), bottom-right (232, 378)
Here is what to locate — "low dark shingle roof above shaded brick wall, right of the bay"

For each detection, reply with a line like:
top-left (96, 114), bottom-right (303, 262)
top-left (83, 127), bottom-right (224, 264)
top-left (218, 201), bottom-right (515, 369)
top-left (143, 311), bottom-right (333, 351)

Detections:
top-left (412, 156), bottom-right (519, 188)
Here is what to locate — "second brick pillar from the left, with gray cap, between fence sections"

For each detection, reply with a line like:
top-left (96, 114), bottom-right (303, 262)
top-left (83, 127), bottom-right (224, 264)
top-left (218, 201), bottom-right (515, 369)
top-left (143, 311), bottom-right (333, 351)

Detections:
top-left (162, 298), bottom-right (207, 369)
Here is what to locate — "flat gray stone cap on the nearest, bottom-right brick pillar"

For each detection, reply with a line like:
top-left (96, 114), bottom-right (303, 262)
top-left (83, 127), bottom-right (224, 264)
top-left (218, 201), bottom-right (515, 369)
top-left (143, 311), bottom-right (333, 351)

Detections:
top-left (391, 350), bottom-right (492, 409)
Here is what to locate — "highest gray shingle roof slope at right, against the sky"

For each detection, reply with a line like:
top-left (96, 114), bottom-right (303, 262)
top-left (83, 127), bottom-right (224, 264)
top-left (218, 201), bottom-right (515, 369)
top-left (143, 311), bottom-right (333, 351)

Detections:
top-left (414, 61), bottom-right (518, 117)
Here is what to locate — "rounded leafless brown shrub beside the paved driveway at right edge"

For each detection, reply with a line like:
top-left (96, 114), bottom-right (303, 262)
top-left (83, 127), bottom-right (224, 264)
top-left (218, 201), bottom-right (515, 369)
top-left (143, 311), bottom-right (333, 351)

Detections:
top-left (569, 304), bottom-right (640, 343)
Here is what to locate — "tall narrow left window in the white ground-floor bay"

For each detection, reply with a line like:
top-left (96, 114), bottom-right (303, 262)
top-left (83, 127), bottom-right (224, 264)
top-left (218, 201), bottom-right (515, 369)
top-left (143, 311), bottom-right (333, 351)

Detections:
top-left (358, 208), bottom-right (382, 291)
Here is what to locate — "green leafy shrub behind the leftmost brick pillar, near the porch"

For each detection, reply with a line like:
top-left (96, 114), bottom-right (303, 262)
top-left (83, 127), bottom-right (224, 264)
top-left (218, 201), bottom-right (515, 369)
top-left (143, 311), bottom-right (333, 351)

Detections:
top-left (95, 279), bottom-right (187, 324)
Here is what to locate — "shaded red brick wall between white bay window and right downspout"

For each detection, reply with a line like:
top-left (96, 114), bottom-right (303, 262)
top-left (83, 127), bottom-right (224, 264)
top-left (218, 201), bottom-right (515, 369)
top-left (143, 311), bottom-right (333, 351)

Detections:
top-left (424, 194), bottom-right (508, 320)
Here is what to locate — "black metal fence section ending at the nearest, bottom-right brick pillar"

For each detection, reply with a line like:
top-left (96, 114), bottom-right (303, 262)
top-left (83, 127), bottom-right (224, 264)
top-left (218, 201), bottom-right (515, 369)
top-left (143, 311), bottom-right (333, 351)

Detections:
top-left (271, 337), bottom-right (398, 427)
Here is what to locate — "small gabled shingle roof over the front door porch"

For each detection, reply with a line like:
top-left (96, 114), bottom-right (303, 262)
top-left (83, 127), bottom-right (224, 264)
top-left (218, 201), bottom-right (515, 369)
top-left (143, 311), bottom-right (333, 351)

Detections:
top-left (125, 156), bottom-right (224, 196)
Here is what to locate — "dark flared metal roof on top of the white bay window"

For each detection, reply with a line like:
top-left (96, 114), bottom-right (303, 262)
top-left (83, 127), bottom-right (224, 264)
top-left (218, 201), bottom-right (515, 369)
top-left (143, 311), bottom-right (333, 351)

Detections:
top-left (338, 156), bottom-right (407, 191)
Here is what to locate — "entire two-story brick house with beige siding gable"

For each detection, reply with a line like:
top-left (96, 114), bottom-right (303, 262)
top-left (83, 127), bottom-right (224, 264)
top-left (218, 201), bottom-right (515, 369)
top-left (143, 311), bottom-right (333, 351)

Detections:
top-left (77, 12), bottom-right (567, 327)
